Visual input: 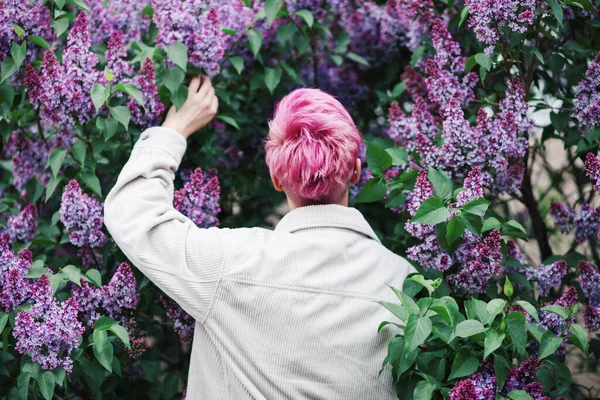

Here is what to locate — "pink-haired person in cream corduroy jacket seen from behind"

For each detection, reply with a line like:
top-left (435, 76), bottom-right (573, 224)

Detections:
top-left (105, 77), bottom-right (414, 400)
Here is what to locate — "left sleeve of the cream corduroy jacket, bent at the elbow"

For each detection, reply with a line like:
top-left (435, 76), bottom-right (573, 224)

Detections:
top-left (104, 127), bottom-right (230, 323)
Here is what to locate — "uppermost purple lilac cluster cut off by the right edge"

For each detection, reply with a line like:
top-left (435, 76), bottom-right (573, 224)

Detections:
top-left (573, 53), bottom-right (600, 131)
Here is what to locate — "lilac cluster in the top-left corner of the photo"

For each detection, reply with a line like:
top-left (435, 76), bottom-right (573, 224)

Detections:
top-left (0, 0), bottom-right (53, 62)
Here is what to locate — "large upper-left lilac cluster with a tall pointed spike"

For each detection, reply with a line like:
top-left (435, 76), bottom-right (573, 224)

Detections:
top-left (25, 12), bottom-right (102, 128)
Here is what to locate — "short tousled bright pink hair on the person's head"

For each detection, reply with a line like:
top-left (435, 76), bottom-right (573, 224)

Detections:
top-left (265, 89), bottom-right (363, 203)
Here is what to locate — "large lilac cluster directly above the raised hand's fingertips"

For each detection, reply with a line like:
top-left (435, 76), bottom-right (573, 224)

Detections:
top-left (152, 0), bottom-right (225, 76)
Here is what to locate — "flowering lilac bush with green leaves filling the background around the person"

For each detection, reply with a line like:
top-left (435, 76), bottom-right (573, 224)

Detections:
top-left (0, 0), bottom-right (600, 399)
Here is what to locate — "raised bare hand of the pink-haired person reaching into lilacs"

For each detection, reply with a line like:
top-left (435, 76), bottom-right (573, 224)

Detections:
top-left (162, 76), bottom-right (219, 139)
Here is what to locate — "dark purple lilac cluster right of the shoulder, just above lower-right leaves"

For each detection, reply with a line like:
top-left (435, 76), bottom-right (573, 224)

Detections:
top-left (448, 229), bottom-right (502, 293)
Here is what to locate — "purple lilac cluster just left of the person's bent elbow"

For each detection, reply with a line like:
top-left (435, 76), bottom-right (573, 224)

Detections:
top-left (60, 179), bottom-right (106, 247)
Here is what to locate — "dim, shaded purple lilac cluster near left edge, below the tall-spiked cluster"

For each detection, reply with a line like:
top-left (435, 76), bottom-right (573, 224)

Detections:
top-left (6, 132), bottom-right (50, 191)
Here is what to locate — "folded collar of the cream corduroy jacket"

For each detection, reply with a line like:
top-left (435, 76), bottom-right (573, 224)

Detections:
top-left (275, 204), bottom-right (381, 243)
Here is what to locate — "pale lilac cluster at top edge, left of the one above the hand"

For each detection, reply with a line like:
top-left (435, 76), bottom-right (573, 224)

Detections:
top-left (86, 0), bottom-right (150, 44)
